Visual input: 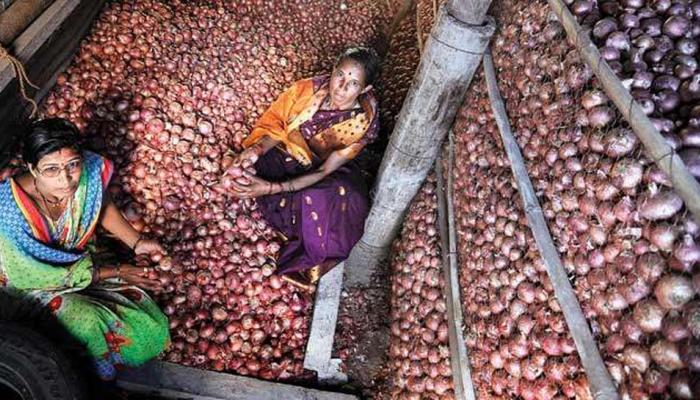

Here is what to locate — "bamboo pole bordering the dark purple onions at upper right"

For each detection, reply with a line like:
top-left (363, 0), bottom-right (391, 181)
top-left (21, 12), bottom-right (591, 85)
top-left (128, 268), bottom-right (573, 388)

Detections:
top-left (547, 0), bottom-right (700, 220)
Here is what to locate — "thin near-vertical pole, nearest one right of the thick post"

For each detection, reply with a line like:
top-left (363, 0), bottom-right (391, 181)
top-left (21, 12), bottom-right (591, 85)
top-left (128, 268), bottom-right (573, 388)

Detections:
top-left (435, 131), bottom-right (476, 400)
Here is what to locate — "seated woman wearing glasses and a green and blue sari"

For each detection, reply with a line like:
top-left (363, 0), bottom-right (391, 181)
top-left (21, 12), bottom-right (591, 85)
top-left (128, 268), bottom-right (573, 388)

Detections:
top-left (0, 118), bottom-right (169, 380)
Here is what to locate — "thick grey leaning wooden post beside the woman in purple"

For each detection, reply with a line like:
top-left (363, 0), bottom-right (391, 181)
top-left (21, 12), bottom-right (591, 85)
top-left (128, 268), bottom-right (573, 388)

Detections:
top-left (346, 1), bottom-right (495, 286)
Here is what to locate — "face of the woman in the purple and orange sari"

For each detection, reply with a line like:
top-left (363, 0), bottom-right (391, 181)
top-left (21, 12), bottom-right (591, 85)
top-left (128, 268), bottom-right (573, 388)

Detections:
top-left (330, 59), bottom-right (372, 110)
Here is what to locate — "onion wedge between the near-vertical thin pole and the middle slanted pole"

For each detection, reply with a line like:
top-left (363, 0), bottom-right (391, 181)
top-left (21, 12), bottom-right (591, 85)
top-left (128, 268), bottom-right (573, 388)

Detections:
top-left (454, 72), bottom-right (591, 400)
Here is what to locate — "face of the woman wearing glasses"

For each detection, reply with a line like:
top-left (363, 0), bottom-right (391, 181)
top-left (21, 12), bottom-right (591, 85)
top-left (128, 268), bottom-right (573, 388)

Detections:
top-left (31, 148), bottom-right (83, 198)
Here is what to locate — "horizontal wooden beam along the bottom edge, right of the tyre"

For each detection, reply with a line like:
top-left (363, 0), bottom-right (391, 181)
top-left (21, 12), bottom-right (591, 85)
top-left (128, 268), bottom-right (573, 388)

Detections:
top-left (117, 361), bottom-right (357, 400)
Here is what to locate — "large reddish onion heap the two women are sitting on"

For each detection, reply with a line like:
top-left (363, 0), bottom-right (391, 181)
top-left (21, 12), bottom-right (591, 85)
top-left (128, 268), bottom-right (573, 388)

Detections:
top-left (32, 0), bottom-right (410, 380)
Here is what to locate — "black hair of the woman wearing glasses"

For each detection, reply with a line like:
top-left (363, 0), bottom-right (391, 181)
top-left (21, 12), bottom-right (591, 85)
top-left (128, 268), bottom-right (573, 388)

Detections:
top-left (22, 118), bottom-right (81, 165)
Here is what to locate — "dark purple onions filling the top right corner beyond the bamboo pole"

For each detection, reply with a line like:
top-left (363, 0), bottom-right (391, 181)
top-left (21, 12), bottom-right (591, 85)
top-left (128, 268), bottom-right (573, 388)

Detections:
top-left (567, 0), bottom-right (700, 178)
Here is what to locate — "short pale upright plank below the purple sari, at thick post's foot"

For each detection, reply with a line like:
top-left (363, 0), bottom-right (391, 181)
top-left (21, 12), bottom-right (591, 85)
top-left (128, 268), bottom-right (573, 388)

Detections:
top-left (304, 263), bottom-right (347, 384)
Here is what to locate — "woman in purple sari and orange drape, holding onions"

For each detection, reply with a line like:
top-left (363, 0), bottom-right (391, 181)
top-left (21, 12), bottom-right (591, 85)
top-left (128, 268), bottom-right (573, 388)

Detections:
top-left (226, 47), bottom-right (379, 290)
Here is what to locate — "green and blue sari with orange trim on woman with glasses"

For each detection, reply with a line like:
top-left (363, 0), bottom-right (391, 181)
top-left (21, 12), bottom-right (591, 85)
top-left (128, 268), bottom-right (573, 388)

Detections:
top-left (0, 152), bottom-right (170, 380)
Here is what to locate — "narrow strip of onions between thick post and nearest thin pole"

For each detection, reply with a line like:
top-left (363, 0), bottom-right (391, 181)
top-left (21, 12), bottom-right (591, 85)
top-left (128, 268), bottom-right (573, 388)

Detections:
top-left (382, 175), bottom-right (454, 400)
